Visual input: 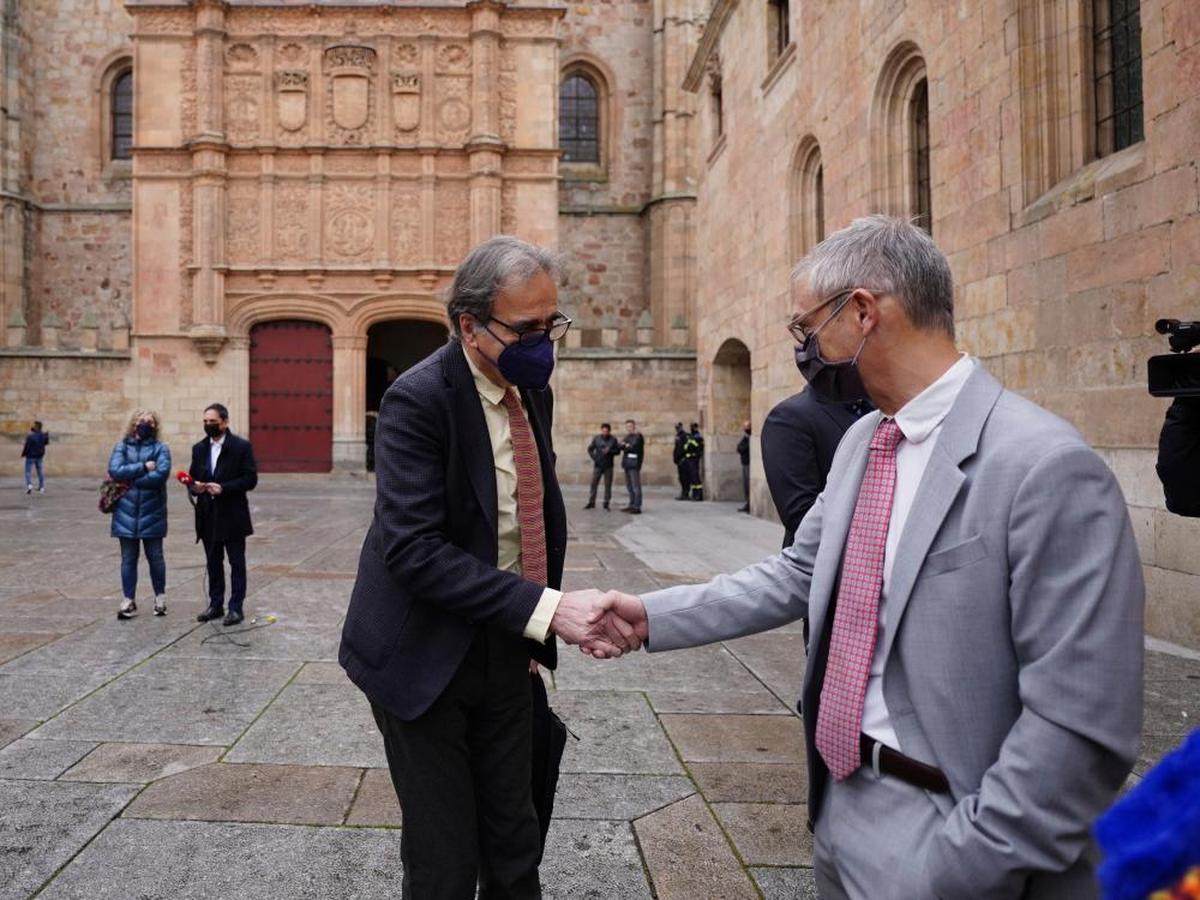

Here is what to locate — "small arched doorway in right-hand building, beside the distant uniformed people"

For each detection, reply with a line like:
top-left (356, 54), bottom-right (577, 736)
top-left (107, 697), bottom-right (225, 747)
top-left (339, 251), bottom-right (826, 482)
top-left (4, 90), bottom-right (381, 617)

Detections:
top-left (704, 337), bottom-right (751, 500)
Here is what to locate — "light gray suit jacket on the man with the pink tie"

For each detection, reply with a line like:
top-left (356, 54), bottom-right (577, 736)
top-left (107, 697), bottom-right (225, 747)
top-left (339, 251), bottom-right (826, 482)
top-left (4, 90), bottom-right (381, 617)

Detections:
top-left (642, 366), bottom-right (1145, 900)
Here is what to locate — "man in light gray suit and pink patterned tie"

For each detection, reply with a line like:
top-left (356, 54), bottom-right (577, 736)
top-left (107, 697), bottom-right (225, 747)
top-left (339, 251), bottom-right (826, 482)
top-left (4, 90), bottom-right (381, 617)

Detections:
top-left (586, 216), bottom-right (1144, 900)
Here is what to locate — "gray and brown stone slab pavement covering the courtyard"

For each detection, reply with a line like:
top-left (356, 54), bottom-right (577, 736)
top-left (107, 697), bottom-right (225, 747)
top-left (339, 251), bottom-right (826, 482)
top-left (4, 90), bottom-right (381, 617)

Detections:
top-left (0, 476), bottom-right (1200, 900)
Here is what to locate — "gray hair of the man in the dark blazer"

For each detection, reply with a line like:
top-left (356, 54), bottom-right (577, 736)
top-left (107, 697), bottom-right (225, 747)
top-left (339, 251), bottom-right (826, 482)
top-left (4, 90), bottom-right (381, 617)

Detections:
top-left (446, 234), bottom-right (558, 340)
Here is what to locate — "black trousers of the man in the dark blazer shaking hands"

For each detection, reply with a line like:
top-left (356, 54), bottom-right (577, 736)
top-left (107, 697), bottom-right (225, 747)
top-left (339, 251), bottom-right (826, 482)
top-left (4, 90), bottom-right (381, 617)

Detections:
top-left (372, 628), bottom-right (541, 900)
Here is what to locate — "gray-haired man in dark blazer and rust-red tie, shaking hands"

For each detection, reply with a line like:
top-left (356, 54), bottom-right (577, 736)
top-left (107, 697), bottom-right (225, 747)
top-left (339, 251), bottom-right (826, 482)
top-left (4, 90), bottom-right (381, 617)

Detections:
top-left (338, 236), bottom-right (638, 900)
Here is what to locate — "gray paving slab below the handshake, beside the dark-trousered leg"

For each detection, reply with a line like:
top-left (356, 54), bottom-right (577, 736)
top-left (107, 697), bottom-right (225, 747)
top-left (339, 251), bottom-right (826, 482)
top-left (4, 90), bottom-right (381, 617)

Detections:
top-left (550, 690), bottom-right (683, 775)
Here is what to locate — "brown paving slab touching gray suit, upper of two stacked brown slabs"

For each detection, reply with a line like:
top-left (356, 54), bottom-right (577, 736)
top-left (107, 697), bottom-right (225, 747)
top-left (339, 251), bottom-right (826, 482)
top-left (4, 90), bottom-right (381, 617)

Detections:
top-left (661, 715), bottom-right (804, 763)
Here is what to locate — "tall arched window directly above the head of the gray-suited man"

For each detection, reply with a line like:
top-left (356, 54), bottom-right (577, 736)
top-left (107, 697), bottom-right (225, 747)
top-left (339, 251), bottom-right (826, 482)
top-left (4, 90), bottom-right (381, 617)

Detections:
top-left (870, 42), bottom-right (934, 233)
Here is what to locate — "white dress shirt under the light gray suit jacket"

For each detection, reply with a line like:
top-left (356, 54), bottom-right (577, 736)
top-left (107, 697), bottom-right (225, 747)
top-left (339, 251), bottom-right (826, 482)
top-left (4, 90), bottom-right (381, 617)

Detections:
top-left (863, 353), bottom-right (977, 750)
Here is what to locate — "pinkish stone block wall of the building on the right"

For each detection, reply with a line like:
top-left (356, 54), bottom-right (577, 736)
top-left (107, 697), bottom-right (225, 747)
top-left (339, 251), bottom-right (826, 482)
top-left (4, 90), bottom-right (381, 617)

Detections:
top-left (689, 0), bottom-right (1200, 646)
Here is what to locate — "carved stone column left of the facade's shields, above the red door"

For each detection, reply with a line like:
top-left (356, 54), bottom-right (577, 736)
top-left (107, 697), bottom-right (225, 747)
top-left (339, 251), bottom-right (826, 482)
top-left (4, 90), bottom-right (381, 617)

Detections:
top-left (188, 0), bottom-right (229, 364)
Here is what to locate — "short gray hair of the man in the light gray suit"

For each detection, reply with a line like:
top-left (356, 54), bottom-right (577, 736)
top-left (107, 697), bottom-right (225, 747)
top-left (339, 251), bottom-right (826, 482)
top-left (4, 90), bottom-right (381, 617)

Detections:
top-left (792, 215), bottom-right (954, 337)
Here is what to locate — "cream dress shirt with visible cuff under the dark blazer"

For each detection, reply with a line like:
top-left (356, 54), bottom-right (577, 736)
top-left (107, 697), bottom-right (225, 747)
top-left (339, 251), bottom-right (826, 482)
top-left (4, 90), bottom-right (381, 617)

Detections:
top-left (462, 347), bottom-right (563, 643)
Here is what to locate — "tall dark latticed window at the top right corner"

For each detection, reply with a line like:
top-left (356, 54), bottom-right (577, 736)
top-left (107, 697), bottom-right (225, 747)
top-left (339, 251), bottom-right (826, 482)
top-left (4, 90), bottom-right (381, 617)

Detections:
top-left (1092, 0), bottom-right (1145, 156)
